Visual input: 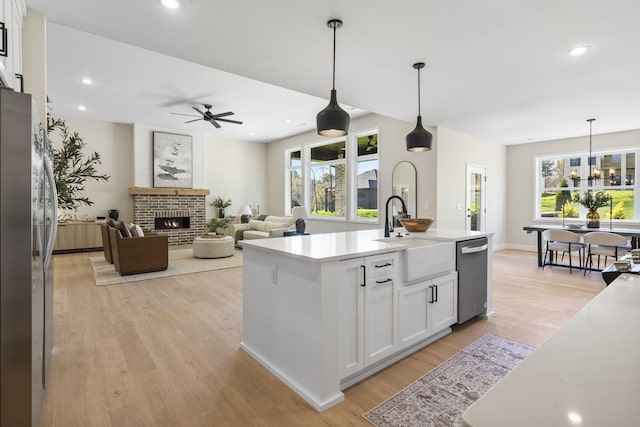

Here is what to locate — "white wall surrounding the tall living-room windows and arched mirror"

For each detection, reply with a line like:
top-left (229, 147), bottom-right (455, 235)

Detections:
top-left (261, 114), bottom-right (436, 233)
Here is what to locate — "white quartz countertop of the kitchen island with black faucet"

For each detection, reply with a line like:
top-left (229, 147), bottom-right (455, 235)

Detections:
top-left (242, 228), bottom-right (493, 262)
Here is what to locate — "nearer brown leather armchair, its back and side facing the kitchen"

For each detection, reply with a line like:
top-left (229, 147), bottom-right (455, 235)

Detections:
top-left (105, 227), bottom-right (169, 276)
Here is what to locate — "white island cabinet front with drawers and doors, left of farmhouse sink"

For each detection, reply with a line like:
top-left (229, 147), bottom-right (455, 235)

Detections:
top-left (336, 253), bottom-right (399, 378)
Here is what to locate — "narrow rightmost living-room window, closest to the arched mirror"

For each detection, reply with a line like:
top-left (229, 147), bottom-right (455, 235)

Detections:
top-left (352, 132), bottom-right (379, 222)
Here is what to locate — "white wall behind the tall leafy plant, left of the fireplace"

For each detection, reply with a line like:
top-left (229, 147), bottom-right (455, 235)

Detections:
top-left (52, 115), bottom-right (133, 221)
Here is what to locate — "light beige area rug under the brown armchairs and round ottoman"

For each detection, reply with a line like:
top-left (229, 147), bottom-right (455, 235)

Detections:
top-left (89, 247), bottom-right (242, 286)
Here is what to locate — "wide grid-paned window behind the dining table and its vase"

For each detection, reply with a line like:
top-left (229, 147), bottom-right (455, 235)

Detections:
top-left (535, 150), bottom-right (640, 221)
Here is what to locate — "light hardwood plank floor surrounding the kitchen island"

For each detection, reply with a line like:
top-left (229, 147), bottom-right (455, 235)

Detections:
top-left (41, 250), bottom-right (604, 427)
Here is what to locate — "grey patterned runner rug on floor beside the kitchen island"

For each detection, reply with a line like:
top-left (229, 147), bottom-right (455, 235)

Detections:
top-left (364, 334), bottom-right (535, 427)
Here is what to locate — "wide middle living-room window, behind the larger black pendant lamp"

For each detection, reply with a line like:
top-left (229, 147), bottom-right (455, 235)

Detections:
top-left (308, 140), bottom-right (347, 218)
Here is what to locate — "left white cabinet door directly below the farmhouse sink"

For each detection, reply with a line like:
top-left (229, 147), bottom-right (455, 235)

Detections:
top-left (398, 282), bottom-right (433, 348)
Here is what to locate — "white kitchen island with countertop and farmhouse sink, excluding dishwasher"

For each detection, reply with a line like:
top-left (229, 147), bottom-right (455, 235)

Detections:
top-left (241, 229), bottom-right (492, 411)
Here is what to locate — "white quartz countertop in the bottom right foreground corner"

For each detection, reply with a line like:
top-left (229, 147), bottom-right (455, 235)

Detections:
top-left (463, 274), bottom-right (640, 427)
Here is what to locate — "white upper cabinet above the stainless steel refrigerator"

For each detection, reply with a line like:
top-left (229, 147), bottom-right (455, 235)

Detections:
top-left (0, 0), bottom-right (27, 91)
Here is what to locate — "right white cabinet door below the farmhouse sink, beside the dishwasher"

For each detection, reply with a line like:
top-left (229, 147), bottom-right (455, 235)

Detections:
top-left (429, 273), bottom-right (458, 334)
